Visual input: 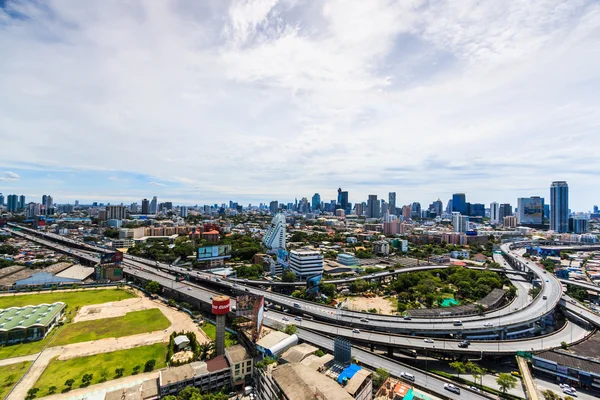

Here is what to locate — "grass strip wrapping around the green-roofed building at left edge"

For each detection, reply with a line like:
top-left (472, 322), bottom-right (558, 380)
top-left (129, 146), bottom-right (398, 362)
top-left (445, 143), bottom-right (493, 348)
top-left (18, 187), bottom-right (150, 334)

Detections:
top-left (0, 289), bottom-right (135, 359)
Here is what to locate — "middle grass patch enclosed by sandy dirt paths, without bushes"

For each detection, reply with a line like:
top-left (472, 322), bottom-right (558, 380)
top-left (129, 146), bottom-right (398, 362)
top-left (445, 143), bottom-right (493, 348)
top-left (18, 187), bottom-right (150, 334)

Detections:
top-left (52, 308), bottom-right (170, 346)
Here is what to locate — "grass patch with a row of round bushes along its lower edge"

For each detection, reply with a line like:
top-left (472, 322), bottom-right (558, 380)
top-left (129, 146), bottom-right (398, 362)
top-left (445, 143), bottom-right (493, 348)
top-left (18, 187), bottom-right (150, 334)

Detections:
top-left (34, 343), bottom-right (167, 397)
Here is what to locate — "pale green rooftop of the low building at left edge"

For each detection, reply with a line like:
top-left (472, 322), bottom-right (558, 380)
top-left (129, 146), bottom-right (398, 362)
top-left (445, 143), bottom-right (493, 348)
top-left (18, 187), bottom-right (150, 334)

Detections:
top-left (0, 301), bottom-right (65, 332)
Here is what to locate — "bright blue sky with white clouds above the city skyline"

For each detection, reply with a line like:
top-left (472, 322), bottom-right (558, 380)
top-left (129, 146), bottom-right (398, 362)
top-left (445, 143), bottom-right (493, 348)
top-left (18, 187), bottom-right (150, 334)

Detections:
top-left (0, 0), bottom-right (600, 211)
